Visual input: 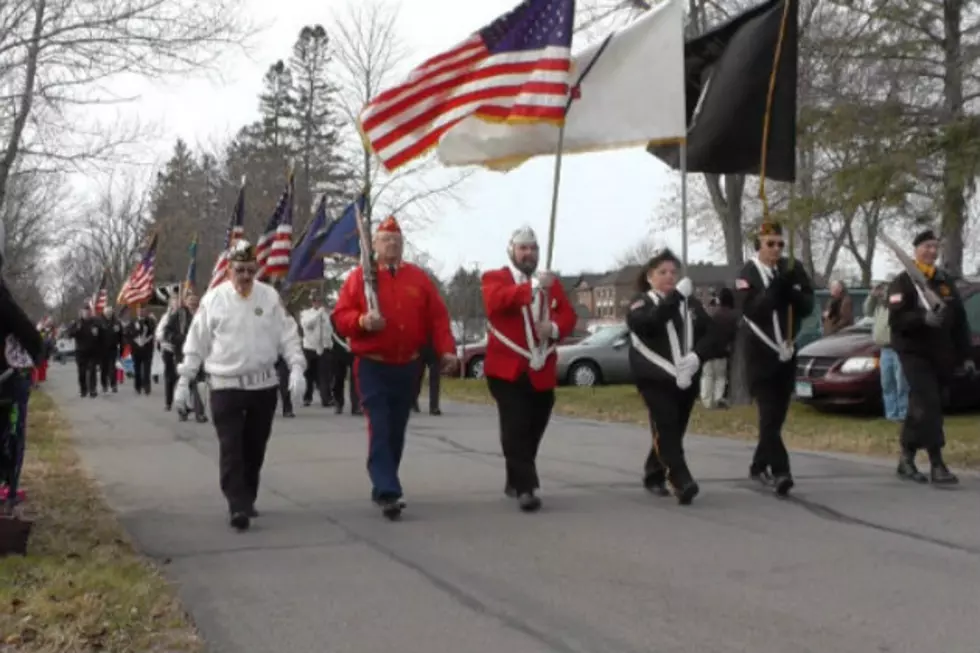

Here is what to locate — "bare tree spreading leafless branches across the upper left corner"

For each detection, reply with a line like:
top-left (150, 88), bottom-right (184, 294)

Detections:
top-left (0, 0), bottom-right (251, 205)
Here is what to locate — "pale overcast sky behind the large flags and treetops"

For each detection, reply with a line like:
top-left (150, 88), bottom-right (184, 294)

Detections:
top-left (72, 0), bottom-right (936, 276)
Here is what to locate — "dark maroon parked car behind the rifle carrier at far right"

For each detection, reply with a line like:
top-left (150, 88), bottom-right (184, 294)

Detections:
top-left (795, 283), bottom-right (980, 411)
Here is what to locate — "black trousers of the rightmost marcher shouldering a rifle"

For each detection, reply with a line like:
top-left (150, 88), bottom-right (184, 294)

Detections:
top-left (898, 354), bottom-right (946, 458)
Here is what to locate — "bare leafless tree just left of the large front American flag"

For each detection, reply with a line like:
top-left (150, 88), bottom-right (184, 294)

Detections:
top-left (327, 0), bottom-right (472, 229)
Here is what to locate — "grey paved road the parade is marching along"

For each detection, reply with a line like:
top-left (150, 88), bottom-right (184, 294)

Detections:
top-left (42, 366), bottom-right (980, 653)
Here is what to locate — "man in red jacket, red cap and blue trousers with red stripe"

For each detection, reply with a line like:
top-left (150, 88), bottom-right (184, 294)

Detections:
top-left (333, 216), bottom-right (459, 519)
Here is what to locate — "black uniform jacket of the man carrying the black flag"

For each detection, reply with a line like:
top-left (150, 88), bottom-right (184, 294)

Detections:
top-left (735, 258), bottom-right (814, 380)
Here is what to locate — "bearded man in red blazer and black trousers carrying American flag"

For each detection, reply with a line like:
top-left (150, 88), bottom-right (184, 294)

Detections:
top-left (482, 227), bottom-right (576, 512)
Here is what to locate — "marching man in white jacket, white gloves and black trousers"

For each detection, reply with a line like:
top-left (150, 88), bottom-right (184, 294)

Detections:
top-left (174, 240), bottom-right (306, 531)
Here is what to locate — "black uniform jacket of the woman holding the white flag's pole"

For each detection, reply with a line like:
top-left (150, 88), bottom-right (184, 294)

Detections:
top-left (626, 290), bottom-right (726, 384)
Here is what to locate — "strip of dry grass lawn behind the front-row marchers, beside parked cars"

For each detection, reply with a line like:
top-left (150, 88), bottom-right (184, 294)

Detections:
top-left (443, 379), bottom-right (980, 469)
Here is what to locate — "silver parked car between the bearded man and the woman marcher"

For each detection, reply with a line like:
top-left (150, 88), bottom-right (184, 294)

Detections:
top-left (557, 324), bottom-right (632, 386)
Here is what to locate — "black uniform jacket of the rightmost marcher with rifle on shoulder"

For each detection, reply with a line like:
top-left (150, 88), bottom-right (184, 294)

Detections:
top-left (888, 269), bottom-right (971, 376)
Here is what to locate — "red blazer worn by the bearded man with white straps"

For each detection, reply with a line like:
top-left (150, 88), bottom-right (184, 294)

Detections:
top-left (482, 267), bottom-right (578, 390)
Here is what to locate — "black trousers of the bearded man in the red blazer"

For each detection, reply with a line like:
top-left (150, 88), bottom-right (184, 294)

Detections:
top-left (487, 375), bottom-right (555, 495)
